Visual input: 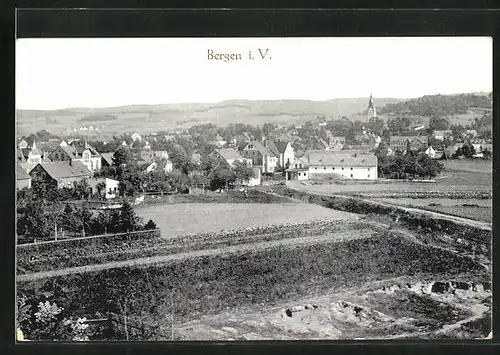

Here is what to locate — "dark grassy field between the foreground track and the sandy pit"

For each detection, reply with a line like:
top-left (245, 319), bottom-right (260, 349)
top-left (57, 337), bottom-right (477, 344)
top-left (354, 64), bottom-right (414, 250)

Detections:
top-left (17, 234), bottom-right (487, 342)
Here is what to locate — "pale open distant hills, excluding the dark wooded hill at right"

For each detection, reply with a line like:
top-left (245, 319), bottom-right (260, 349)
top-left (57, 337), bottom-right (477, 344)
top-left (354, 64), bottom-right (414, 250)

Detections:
top-left (17, 97), bottom-right (401, 134)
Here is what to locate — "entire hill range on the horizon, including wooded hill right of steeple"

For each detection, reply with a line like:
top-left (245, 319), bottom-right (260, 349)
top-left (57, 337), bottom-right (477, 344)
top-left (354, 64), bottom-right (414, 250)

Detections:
top-left (16, 93), bottom-right (491, 135)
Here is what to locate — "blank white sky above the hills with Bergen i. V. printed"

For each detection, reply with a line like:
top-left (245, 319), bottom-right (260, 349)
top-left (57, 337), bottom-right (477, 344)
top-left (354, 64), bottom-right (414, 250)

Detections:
top-left (16, 37), bottom-right (493, 109)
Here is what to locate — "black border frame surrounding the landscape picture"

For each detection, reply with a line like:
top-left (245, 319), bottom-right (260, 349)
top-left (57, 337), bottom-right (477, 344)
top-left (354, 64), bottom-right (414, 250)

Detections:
top-left (0, 4), bottom-right (500, 354)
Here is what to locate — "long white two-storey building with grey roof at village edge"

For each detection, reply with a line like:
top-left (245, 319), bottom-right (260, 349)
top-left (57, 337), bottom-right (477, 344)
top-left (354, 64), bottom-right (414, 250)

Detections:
top-left (287, 151), bottom-right (378, 180)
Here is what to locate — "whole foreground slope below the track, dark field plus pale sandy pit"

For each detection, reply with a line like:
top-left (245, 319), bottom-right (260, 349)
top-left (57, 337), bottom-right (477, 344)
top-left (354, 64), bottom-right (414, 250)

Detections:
top-left (18, 232), bottom-right (491, 340)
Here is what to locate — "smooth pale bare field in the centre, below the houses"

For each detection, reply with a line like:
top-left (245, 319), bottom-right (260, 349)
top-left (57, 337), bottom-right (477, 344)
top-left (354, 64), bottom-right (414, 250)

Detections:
top-left (137, 203), bottom-right (358, 238)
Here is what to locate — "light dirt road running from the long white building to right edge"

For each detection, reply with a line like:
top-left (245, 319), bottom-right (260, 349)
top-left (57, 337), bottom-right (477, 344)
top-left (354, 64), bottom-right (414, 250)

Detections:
top-left (288, 184), bottom-right (491, 231)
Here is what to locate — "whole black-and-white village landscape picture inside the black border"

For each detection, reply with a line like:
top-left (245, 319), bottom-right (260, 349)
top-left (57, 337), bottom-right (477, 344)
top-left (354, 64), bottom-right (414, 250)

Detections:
top-left (15, 37), bottom-right (493, 342)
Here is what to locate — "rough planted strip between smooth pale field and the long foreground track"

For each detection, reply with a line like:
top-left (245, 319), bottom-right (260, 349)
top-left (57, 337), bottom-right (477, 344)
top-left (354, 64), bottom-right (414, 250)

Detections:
top-left (17, 220), bottom-right (366, 274)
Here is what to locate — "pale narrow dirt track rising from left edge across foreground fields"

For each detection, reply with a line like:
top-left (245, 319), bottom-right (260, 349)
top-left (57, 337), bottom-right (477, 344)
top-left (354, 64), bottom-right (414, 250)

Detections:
top-left (17, 229), bottom-right (373, 281)
